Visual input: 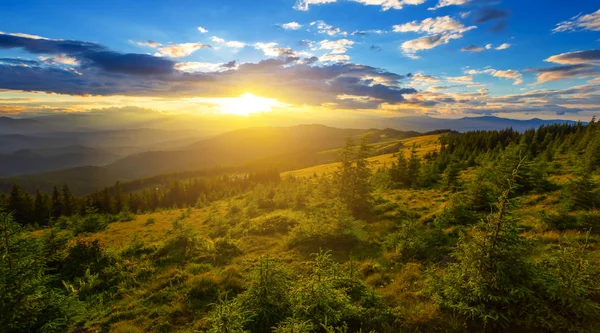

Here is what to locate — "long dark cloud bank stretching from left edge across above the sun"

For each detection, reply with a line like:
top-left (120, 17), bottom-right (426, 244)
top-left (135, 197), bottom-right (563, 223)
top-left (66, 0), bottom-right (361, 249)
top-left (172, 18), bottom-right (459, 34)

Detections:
top-left (0, 34), bottom-right (416, 107)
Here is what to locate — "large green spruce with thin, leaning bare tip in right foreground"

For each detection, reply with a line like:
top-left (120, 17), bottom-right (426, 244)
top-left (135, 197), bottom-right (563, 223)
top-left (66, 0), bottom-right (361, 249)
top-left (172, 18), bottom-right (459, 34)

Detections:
top-left (435, 164), bottom-right (534, 331)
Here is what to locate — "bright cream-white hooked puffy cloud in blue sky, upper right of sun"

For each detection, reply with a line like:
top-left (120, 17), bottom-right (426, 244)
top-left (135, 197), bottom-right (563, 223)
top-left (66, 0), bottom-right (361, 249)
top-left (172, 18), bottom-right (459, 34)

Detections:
top-left (393, 16), bottom-right (476, 58)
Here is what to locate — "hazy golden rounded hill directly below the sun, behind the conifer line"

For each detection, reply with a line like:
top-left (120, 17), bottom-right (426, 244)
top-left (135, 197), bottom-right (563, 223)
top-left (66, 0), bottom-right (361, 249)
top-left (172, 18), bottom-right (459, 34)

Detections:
top-left (0, 125), bottom-right (419, 194)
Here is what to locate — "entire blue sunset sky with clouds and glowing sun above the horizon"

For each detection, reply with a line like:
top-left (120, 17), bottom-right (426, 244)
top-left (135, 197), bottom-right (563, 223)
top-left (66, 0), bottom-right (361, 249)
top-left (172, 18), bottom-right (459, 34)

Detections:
top-left (0, 0), bottom-right (600, 121)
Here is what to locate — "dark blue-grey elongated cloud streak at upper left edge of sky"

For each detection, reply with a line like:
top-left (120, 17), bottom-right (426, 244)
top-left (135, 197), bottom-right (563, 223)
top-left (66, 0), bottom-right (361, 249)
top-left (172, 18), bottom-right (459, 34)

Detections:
top-left (0, 34), bottom-right (175, 75)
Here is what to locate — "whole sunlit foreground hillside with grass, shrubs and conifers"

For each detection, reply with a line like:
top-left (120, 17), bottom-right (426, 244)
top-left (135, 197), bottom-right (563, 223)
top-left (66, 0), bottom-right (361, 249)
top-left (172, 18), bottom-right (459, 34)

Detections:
top-left (0, 123), bottom-right (600, 333)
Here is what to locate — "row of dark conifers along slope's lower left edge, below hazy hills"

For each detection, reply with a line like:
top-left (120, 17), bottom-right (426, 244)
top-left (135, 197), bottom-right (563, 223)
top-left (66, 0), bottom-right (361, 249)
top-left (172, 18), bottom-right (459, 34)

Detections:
top-left (0, 168), bottom-right (281, 226)
